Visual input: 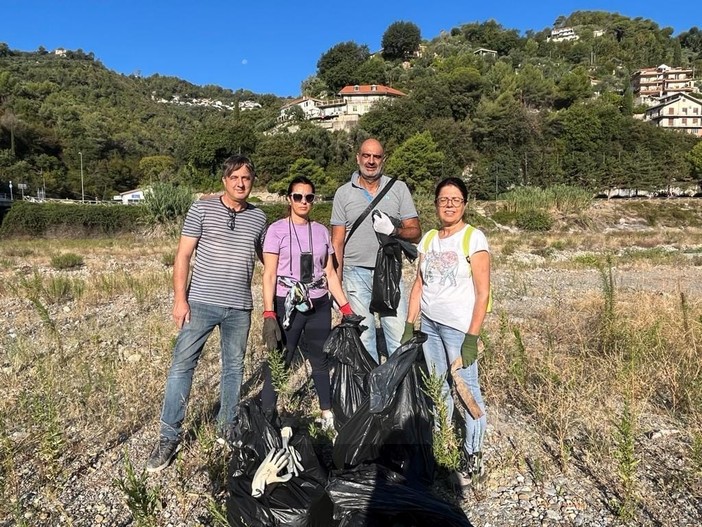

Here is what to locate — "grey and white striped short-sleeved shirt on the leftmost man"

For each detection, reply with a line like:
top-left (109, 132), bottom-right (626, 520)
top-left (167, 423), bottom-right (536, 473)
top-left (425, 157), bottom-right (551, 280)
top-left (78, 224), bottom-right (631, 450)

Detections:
top-left (182, 198), bottom-right (266, 309)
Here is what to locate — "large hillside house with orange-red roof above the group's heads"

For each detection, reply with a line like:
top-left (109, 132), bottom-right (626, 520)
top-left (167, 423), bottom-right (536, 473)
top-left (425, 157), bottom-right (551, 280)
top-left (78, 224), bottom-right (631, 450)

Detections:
top-left (278, 84), bottom-right (405, 130)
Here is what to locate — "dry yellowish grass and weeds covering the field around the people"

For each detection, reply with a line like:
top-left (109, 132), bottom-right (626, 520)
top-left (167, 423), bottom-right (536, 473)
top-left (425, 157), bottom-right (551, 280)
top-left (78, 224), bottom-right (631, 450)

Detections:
top-left (0, 205), bottom-right (702, 525)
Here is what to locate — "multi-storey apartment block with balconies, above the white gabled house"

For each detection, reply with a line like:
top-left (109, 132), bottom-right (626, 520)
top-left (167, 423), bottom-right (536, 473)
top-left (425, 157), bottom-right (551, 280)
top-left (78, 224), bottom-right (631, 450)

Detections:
top-left (631, 64), bottom-right (697, 106)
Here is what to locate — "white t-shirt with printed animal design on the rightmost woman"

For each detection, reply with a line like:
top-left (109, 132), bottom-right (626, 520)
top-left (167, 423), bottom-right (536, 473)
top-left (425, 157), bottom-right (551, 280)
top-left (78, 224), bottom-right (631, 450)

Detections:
top-left (417, 225), bottom-right (490, 332)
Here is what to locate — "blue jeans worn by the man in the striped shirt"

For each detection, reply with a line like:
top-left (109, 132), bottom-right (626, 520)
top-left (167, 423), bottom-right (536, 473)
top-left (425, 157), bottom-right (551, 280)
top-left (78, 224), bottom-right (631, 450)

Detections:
top-left (161, 302), bottom-right (251, 440)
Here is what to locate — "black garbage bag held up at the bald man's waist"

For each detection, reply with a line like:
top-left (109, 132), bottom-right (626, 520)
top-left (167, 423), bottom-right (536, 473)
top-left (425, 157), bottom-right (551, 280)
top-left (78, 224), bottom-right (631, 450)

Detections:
top-left (370, 229), bottom-right (417, 316)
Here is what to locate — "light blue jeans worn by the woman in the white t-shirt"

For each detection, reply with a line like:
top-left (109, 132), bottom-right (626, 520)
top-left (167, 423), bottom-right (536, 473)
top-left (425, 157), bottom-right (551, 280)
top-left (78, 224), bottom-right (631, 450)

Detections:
top-left (421, 316), bottom-right (487, 455)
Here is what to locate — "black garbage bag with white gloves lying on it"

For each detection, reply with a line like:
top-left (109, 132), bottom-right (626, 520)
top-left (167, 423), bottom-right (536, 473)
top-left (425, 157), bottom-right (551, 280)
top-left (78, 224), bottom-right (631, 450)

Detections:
top-left (227, 401), bottom-right (333, 527)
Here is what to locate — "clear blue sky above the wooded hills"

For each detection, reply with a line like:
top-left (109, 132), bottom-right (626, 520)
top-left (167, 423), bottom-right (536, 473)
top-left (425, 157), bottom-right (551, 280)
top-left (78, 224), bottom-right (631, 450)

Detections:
top-left (5, 0), bottom-right (702, 96)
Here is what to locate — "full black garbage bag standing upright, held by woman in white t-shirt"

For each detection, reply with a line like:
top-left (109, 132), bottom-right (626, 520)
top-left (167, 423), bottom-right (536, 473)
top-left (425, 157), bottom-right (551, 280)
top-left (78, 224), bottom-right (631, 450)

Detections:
top-left (333, 333), bottom-right (436, 485)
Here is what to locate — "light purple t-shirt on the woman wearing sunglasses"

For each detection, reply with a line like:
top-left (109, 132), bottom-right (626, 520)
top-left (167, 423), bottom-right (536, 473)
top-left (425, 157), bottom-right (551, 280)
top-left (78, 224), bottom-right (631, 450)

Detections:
top-left (263, 218), bottom-right (334, 298)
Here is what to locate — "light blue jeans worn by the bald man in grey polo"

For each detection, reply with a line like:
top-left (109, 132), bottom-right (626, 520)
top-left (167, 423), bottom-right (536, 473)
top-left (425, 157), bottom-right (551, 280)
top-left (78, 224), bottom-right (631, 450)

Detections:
top-left (344, 266), bottom-right (407, 364)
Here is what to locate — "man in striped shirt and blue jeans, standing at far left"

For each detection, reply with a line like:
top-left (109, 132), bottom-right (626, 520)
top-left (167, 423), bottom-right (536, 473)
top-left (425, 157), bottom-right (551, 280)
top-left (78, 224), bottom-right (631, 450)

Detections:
top-left (146, 155), bottom-right (266, 472)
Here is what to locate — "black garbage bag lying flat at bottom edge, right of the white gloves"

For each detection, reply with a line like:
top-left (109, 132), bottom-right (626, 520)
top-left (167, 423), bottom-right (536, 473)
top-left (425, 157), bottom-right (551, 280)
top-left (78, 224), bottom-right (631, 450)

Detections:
top-left (327, 465), bottom-right (471, 527)
